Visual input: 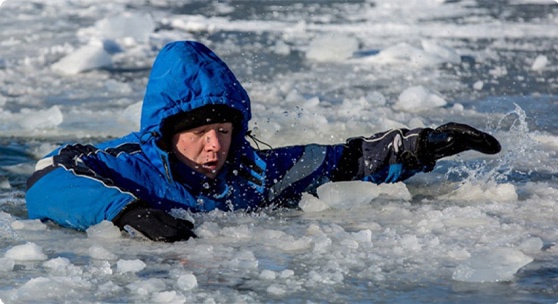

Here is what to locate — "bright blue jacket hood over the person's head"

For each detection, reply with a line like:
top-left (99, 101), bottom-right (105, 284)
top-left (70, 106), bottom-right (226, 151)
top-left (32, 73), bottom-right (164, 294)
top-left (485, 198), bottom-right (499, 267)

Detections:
top-left (140, 41), bottom-right (251, 137)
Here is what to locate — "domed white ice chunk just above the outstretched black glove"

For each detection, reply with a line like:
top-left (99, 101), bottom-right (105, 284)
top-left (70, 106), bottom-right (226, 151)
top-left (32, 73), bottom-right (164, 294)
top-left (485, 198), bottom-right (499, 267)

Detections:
top-left (393, 86), bottom-right (447, 113)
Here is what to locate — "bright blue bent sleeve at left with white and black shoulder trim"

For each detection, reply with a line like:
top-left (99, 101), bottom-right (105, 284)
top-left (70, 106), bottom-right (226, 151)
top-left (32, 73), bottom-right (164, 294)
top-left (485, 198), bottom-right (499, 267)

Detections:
top-left (26, 145), bottom-right (136, 230)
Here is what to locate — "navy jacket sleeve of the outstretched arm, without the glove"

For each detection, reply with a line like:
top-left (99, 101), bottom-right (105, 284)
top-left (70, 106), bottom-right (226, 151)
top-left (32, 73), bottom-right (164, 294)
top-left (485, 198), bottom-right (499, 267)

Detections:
top-left (260, 129), bottom-right (434, 204)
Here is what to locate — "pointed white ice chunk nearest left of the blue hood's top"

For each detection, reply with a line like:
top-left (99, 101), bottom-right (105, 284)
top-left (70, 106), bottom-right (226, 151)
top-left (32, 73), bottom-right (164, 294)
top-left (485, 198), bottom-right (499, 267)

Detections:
top-left (51, 43), bottom-right (112, 75)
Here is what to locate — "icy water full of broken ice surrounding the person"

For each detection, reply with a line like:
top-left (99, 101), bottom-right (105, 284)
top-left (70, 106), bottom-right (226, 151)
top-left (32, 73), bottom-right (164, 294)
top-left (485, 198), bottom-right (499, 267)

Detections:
top-left (0, 0), bottom-right (558, 303)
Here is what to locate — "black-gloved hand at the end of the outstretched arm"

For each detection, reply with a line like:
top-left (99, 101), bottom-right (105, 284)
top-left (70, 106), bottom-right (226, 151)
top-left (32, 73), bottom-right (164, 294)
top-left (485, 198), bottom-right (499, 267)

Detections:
top-left (417, 122), bottom-right (502, 163)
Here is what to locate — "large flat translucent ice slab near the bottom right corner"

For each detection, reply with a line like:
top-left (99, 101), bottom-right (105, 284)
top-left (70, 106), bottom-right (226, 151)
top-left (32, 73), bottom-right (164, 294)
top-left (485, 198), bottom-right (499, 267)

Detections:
top-left (452, 247), bottom-right (533, 283)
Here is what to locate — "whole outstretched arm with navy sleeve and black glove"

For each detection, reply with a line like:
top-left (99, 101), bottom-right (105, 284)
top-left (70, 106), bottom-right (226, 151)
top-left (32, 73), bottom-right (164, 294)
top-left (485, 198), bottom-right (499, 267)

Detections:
top-left (259, 123), bottom-right (501, 205)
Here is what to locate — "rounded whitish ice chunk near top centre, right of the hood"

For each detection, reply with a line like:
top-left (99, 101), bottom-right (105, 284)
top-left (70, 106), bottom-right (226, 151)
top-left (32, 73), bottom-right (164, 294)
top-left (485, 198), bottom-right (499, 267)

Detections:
top-left (306, 34), bottom-right (358, 62)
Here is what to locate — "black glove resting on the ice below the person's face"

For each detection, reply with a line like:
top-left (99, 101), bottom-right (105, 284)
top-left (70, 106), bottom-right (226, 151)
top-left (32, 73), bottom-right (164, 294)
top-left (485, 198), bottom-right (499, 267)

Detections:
top-left (112, 201), bottom-right (196, 242)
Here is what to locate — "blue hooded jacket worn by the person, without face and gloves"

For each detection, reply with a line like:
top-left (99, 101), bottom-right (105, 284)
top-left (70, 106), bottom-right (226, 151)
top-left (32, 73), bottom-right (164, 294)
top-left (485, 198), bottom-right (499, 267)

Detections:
top-left (26, 41), bottom-right (428, 229)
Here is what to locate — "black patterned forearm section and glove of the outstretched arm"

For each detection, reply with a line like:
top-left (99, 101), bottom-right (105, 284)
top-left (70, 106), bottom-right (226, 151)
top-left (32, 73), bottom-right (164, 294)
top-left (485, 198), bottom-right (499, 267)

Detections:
top-left (332, 122), bottom-right (501, 181)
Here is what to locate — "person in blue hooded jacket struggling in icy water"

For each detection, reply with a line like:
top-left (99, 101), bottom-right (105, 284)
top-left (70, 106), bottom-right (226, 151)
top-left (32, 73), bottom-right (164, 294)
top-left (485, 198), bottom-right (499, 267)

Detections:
top-left (26, 41), bottom-right (501, 242)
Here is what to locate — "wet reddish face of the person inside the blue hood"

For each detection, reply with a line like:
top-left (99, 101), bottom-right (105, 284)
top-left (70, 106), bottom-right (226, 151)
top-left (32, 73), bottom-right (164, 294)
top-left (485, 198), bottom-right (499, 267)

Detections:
top-left (172, 122), bottom-right (233, 179)
